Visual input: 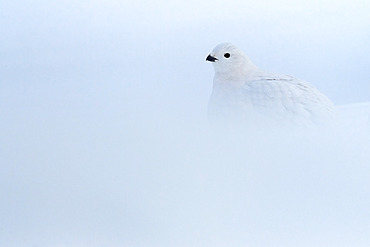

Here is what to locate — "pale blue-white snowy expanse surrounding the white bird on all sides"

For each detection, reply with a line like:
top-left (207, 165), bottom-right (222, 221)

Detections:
top-left (0, 0), bottom-right (370, 247)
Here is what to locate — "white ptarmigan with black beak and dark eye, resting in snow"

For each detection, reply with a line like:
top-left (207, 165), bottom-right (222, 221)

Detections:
top-left (206, 43), bottom-right (334, 126)
